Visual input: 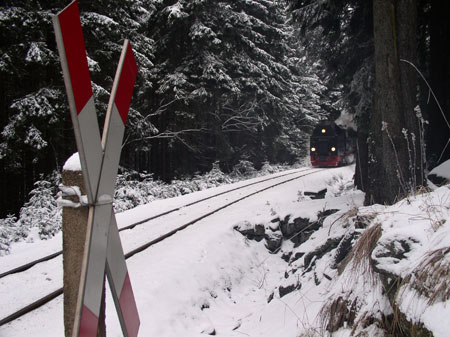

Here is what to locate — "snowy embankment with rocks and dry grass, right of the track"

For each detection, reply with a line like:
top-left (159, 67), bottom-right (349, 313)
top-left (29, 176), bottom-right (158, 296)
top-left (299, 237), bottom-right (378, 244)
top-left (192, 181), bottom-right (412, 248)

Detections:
top-left (236, 163), bottom-right (450, 337)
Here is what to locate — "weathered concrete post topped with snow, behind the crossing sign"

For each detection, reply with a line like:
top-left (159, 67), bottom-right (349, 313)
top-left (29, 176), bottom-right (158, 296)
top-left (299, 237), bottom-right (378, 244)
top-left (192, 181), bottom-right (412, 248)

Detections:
top-left (62, 170), bottom-right (106, 337)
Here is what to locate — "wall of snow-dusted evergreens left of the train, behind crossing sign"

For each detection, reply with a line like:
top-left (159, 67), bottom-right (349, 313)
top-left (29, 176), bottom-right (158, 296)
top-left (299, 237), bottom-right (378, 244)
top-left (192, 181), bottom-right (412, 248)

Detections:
top-left (0, 0), bottom-right (329, 216)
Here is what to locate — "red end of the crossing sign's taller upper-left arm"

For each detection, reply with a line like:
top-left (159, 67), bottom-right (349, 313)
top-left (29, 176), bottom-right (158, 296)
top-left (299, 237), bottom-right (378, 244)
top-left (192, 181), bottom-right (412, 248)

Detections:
top-left (58, 1), bottom-right (92, 114)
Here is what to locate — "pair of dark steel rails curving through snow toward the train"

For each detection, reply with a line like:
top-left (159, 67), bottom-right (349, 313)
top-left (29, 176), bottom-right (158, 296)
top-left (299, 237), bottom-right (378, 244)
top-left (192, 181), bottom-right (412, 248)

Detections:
top-left (0, 168), bottom-right (323, 326)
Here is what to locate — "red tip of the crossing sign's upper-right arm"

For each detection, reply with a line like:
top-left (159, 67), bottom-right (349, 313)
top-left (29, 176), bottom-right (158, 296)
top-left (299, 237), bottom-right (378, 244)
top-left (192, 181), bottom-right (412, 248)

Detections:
top-left (114, 44), bottom-right (138, 125)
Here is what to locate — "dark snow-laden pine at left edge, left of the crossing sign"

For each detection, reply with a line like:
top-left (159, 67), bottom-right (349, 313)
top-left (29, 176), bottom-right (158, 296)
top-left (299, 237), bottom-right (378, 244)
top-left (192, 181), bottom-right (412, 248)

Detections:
top-left (0, 1), bottom-right (73, 216)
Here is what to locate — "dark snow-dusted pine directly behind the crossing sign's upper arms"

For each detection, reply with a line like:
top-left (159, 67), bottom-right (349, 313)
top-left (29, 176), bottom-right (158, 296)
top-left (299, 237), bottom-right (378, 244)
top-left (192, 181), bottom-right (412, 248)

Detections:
top-left (80, 0), bottom-right (157, 170)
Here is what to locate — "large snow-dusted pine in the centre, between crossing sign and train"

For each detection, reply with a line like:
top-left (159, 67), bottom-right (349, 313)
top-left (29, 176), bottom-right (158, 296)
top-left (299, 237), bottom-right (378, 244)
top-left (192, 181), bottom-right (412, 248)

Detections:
top-left (149, 0), bottom-right (322, 178)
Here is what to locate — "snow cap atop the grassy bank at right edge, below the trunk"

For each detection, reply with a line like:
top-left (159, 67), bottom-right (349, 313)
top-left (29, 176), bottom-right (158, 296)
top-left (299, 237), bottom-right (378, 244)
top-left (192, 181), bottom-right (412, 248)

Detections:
top-left (373, 185), bottom-right (450, 278)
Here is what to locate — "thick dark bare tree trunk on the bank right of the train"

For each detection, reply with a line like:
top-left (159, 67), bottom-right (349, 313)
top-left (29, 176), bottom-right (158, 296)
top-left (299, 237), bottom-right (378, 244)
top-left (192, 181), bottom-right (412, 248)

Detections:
top-left (366, 0), bottom-right (419, 204)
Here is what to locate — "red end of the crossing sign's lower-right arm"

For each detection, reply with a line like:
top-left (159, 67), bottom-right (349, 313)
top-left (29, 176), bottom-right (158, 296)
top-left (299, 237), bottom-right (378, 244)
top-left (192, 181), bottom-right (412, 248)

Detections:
top-left (119, 273), bottom-right (141, 337)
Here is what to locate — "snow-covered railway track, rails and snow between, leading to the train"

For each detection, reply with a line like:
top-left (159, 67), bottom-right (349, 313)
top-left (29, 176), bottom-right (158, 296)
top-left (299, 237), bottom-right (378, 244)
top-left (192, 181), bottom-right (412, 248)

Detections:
top-left (0, 168), bottom-right (322, 326)
